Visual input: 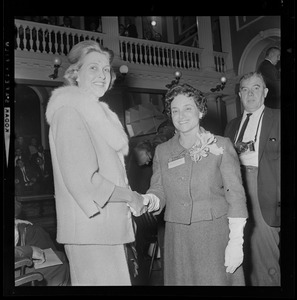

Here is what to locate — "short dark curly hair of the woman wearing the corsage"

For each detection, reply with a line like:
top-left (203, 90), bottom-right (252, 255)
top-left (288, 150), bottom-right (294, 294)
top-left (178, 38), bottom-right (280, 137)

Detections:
top-left (165, 83), bottom-right (207, 119)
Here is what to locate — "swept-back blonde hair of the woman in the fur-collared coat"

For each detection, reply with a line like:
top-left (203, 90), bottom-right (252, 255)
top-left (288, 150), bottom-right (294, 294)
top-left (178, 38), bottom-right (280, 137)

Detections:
top-left (64, 40), bottom-right (116, 90)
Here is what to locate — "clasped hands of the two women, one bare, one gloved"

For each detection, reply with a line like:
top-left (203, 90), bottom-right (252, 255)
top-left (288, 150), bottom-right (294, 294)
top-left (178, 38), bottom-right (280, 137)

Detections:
top-left (111, 186), bottom-right (160, 217)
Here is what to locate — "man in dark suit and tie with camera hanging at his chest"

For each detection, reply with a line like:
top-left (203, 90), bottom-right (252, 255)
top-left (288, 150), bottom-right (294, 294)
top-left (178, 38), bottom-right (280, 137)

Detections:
top-left (225, 72), bottom-right (281, 286)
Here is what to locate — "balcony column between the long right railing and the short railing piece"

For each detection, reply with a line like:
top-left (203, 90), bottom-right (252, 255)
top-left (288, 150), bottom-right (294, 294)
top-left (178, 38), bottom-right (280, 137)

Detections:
top-left (198, 16), bottom-right (215, 71)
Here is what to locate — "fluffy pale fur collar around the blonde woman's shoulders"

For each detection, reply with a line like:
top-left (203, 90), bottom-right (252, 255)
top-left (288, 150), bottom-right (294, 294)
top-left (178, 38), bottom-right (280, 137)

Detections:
top-left (46, 86), bottom-right (129, 155)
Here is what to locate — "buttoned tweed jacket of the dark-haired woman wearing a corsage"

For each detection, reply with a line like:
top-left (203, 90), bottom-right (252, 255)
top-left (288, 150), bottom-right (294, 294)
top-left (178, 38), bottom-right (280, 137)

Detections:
top-left (147, 134), bottom-right (248, 224)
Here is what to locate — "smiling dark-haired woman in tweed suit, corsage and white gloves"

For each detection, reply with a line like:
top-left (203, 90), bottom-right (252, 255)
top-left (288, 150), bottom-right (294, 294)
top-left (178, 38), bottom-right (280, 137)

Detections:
top-left (143, 84), bottom-right (248, 286)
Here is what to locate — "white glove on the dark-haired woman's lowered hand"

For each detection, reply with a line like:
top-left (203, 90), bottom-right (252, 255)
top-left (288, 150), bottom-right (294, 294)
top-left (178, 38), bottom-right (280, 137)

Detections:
top-left (224, 218), bottom-right (246, 273)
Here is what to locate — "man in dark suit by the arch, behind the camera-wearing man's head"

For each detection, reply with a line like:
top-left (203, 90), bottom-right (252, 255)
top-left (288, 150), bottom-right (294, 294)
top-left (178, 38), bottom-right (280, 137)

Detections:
top-left (258, 47), bottom-right (281, 108)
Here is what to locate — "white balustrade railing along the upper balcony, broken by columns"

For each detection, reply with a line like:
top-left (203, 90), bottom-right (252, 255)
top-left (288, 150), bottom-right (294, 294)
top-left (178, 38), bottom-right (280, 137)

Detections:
top-left (15, 20), bottom-right (227, 73)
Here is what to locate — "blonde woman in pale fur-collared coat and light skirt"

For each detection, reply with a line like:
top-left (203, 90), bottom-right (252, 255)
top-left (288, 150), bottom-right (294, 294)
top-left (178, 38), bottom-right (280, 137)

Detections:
top-left (46, 40), bottom-right (145, 285)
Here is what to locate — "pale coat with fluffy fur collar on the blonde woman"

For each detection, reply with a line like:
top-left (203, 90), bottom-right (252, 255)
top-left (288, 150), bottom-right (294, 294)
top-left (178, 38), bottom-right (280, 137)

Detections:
top-left (46, 86), bottom-right (134, 245)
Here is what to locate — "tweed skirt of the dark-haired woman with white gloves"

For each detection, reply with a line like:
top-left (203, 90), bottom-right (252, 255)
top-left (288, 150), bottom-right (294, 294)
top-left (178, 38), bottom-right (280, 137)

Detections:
top-left (164, 216), bottom-right (245, 286)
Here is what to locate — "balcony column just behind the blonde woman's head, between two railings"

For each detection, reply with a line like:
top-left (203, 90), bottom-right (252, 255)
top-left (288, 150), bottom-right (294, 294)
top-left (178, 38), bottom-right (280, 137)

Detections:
top-left (102, 16), bottom-right (120, 58)
